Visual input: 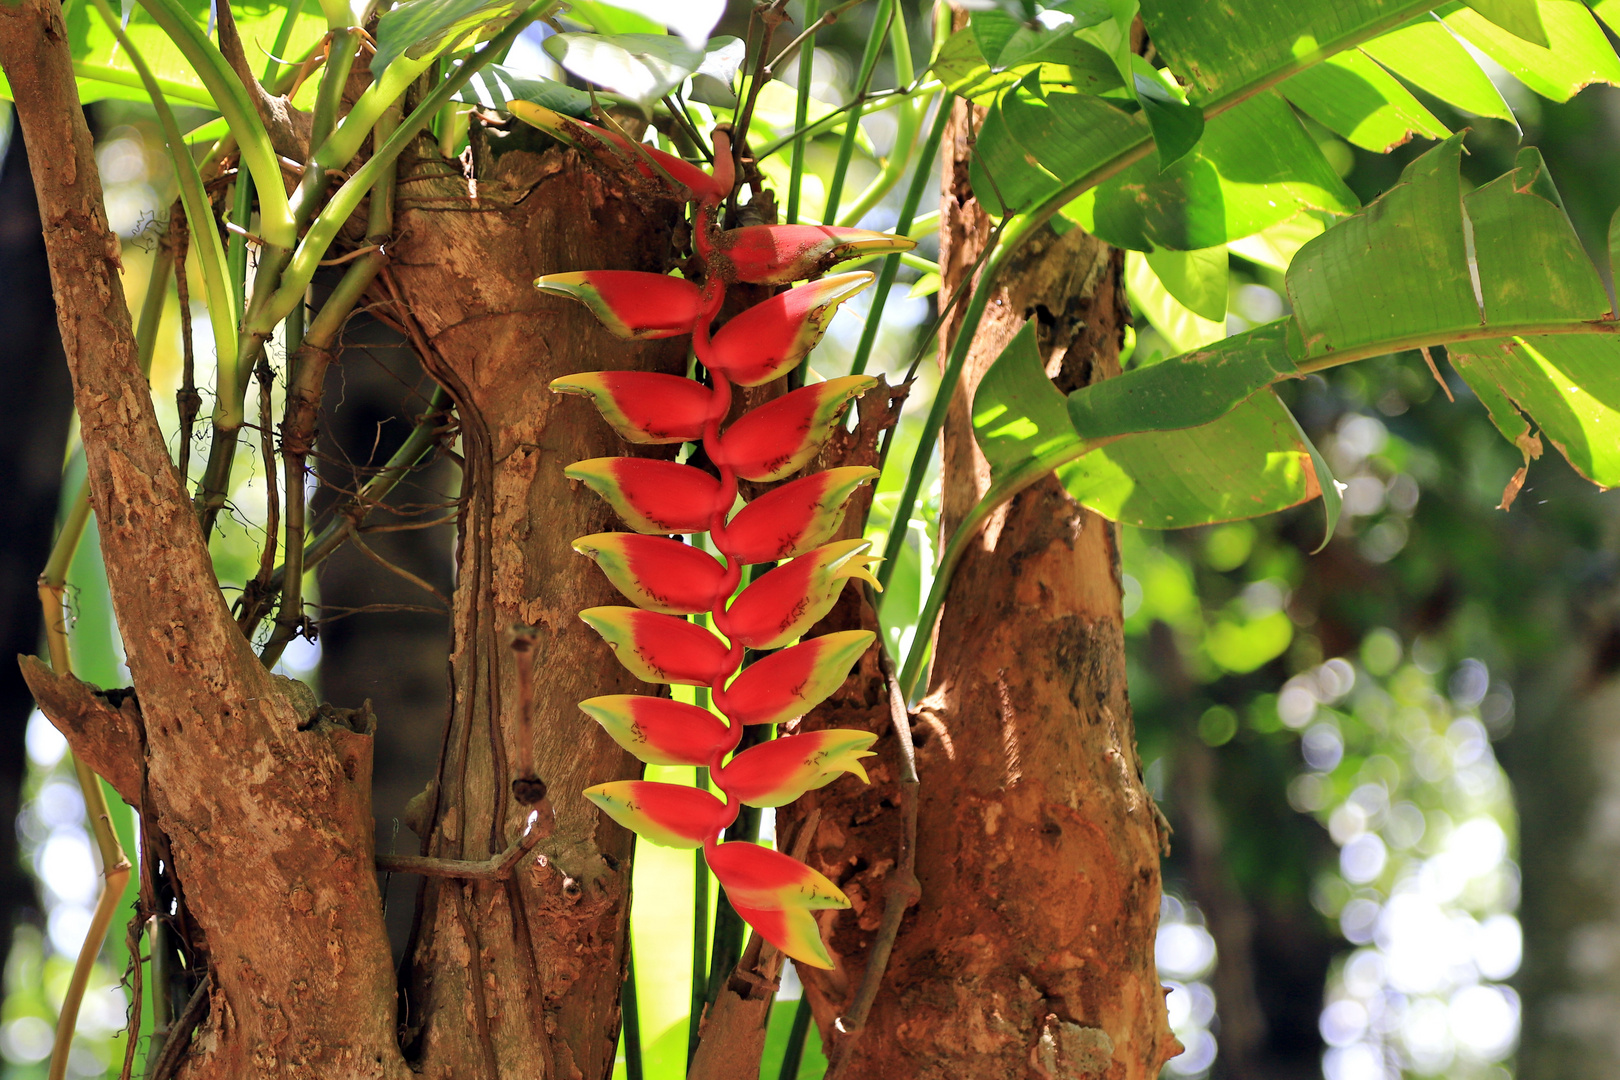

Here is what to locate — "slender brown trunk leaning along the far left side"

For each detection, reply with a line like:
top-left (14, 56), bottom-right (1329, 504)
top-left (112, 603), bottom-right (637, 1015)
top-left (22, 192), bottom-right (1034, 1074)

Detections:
top-left (0, 0), bottom-right (407, 1077)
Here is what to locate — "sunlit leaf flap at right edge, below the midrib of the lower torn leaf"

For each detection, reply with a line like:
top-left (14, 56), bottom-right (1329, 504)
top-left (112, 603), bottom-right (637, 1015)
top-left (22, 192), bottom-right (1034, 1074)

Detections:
top-left (1448, 335), bottom-right (1620, 487)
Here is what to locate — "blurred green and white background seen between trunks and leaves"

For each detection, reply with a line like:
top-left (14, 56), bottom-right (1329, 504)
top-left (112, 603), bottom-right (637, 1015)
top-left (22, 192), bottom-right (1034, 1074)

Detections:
top-left (0, 2), bottom-right (1620, 1080)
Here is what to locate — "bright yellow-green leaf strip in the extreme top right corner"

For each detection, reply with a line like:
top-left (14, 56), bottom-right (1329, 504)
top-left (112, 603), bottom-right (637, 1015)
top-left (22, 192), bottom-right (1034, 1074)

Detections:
top-left (1445, 0), bottom-right (1620, 102)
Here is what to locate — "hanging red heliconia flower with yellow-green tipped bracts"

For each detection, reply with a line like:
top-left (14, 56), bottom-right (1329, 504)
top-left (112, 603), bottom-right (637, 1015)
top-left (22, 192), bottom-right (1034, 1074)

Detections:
top-left (524, 102), bottom-right (914, 968)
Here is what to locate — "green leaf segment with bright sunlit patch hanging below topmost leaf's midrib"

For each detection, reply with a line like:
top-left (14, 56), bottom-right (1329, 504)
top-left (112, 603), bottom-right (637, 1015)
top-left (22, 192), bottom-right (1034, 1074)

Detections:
top-left (1062, 94), bottom-right (1358, 251)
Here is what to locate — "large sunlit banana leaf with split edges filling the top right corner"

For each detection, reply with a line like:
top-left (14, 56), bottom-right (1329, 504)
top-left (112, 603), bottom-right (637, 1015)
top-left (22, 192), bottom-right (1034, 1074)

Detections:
top-left (965, 0), bottom-right (1620, 251)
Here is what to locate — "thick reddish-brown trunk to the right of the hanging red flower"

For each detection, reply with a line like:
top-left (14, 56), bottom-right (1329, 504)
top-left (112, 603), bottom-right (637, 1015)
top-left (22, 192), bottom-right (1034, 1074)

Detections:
top-left (782, 95), bottom-right (1178, 1080)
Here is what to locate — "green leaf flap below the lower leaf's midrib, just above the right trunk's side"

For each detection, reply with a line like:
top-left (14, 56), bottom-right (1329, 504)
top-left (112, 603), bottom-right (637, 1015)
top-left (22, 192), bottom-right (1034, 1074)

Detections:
top-left (1058, 390), bottom-right (1333, 529)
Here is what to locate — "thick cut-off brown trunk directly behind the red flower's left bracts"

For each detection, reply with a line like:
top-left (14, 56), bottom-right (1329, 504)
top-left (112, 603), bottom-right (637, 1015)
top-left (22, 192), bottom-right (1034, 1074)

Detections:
top-left (390, 151), bottom-right (685, 1080)
